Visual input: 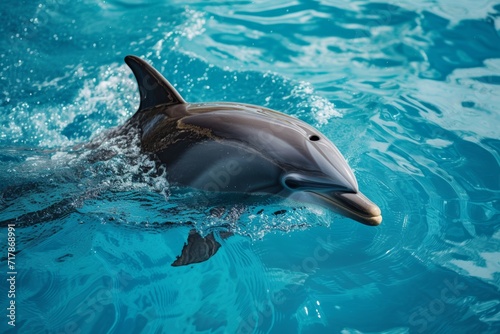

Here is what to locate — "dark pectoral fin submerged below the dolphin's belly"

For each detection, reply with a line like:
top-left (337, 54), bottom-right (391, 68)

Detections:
top-left (172, 230), bottom-right (232, 267)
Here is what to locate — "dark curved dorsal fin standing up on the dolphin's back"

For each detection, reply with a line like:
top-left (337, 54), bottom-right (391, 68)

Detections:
top-left (125, 56), bottom-right (186, 112)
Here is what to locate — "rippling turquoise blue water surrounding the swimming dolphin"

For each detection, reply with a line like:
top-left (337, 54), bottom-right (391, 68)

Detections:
top-left (0, 0), bottom-right (500, 333)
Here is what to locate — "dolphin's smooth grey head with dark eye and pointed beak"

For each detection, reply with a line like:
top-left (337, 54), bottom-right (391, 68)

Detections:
top-left (282, 123), bottom-right (382, 226)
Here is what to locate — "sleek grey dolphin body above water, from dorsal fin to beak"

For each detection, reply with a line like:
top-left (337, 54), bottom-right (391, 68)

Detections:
top-left (125, 56), bottom-right (382, 231)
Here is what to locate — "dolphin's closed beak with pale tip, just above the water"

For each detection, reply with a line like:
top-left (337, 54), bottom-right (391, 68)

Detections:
top-left (310, 191), bottom-right (382, 226)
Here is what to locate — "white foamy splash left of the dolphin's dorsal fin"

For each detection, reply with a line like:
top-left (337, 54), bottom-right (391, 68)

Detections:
top-left (0, 64), bottom-right (139, 148)
